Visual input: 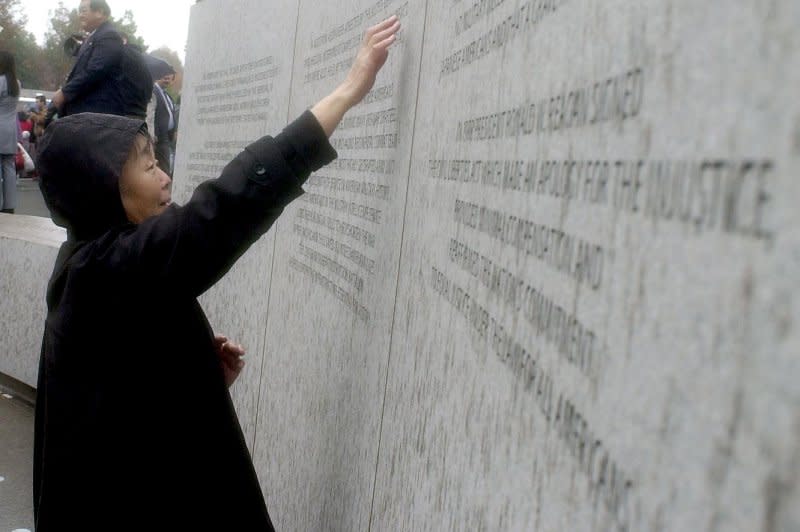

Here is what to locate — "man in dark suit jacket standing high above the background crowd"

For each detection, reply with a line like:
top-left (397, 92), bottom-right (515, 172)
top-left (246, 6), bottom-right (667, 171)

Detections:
top-left (53, 0), bottom-right (126, 118)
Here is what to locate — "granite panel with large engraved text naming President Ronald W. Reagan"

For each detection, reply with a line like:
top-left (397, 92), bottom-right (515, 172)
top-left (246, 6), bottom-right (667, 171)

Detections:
top-left (372, 0), bottom-right (800, 531)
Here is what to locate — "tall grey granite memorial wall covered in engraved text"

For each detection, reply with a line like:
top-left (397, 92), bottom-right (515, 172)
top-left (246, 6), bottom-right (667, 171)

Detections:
top-left (175, 0), bottom-right (800, 532)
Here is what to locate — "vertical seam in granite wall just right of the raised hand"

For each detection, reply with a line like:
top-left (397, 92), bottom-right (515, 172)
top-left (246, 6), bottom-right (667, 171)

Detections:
top-left (367, 0), bottom-right (428, 532)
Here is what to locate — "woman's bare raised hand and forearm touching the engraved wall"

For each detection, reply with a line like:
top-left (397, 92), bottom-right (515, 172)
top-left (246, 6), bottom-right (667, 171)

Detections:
top-left (311, 15), bottom-right (400, 137)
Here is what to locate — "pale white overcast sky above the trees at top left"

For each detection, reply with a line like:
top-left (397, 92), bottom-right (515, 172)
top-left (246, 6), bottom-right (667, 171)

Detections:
top-left (20, 0), bottom-right (195, 60)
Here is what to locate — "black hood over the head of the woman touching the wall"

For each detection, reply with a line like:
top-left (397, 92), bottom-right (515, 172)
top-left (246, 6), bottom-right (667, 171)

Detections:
top-left (36, 113), bottom-right (147, 241)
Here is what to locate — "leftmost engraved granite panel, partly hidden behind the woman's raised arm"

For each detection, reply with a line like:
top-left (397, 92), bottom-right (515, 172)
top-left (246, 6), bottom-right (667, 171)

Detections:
top-left (173, 0), bottom-right (297, 449)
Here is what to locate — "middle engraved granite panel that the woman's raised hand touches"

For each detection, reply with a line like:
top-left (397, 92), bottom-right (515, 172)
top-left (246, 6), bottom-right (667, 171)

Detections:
top-left (254, 0), bottom-right (424, 530)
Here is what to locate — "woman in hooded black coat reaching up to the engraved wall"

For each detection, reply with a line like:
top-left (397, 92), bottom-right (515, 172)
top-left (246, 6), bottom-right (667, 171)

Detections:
top-left (33, 17), bottom-right (400, 532)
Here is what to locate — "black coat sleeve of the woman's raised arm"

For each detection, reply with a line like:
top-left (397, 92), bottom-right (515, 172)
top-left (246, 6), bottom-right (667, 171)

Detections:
top-left (99, 111), bottom-right (336, 297)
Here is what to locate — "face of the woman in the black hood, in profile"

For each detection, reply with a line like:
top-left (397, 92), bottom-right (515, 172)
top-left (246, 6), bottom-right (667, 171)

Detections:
top-left (119, 135), bottom-right (172, 224)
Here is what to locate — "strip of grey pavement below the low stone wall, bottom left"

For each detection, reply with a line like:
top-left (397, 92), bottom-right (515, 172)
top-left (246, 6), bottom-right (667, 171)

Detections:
top-left (0, 384), bottom-right (33, 532)
